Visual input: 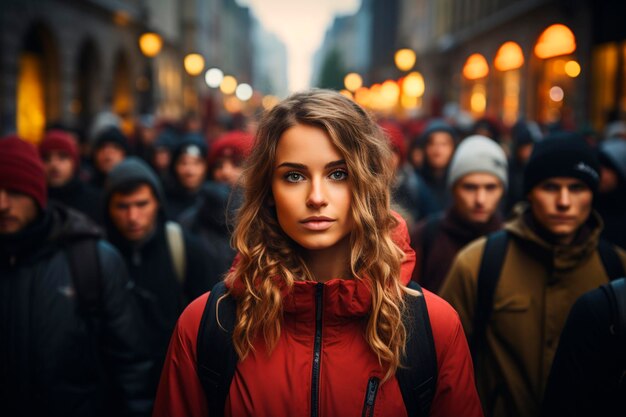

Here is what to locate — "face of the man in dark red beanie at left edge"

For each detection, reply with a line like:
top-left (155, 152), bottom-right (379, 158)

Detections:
top-left (0, 188), bottom-right (39, 235)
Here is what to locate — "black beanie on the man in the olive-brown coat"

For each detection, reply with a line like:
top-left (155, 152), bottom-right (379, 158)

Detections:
top-left (524, 132), bottom-right (600, 194)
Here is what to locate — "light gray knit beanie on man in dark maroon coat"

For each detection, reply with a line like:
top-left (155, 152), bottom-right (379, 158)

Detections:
top-left (448, 135), bottom-right (508, 188)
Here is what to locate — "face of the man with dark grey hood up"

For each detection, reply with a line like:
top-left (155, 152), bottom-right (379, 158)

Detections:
top-left (109, 184), bottom-right (159, 242)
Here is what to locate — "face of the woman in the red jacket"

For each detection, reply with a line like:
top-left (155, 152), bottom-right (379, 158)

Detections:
top-left (272, 125), bottom-right (354, 255)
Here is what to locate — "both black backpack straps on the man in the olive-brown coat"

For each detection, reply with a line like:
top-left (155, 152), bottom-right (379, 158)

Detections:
top-left (470, 229), bottom-right (624, 362)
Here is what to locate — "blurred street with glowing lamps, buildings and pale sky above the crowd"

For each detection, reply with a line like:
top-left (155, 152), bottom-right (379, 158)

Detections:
top-left (0, 0), bottom-right (626, 143)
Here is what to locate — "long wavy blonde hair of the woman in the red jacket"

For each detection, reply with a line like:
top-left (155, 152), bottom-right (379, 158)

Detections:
top-left (226, 90), bottom-right (407, 379)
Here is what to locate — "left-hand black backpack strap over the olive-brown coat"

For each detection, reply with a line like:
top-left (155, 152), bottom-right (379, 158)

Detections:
top-left (470, 229), bottom-right (509, 362)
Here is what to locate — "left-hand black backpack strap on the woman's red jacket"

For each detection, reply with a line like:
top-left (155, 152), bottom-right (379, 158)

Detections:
top-left (196, 281), bottom-right (237, 417)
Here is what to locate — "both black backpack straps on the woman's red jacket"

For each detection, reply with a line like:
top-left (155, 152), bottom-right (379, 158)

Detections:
top-left (196, 281), bottom-right (437, 417)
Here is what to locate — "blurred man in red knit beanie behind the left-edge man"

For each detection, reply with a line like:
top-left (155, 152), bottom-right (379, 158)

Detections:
top-left (39, 130), bottom-right (102, 223)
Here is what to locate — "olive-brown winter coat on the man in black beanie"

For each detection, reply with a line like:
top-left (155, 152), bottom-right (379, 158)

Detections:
top-left (441, 203), bottom-right (626, 417)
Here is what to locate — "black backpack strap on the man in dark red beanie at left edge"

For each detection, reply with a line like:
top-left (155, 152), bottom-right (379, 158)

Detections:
top-left (66, 239), bottom-right (102, 316)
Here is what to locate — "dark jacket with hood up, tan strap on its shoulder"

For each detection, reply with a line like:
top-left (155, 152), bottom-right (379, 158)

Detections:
top-left (105, 157), bottom-right (213, 391)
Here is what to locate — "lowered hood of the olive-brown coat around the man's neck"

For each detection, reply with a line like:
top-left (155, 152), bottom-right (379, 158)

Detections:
top-left (504, 202), bottom-right (604, 270)
